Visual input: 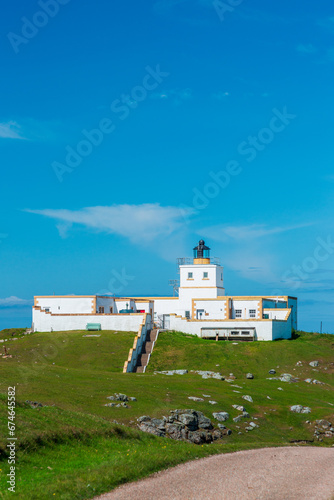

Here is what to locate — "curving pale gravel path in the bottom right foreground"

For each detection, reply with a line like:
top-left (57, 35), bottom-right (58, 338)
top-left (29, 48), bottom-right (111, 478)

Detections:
top-left (95, 447), bottom-right (334, 500)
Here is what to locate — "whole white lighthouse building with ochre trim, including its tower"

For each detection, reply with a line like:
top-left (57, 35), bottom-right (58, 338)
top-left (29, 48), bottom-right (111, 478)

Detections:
top-left (33, 240), bottom-right (297, 340)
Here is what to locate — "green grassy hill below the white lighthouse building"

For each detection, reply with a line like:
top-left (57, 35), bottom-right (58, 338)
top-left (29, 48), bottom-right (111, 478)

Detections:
top-left (0, 331), bottom-right (334, 499)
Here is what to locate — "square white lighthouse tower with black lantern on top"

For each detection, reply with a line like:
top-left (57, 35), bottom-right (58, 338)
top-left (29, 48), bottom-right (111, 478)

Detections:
top-left (179, 240), bottom-right (225, 319)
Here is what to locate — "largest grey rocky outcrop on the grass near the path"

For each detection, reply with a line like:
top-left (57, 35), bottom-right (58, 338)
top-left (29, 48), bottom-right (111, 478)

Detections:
top-left (137, 409), bottom-right (232, 444)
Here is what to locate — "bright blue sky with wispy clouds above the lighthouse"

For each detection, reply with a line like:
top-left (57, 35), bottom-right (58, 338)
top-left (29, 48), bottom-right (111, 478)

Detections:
top-left (0, 0), bottom-right (334, 333)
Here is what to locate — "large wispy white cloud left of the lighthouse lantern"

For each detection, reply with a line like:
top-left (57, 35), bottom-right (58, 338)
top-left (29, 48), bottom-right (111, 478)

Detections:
top-left (26, 203), bottom-right (193, 243)
